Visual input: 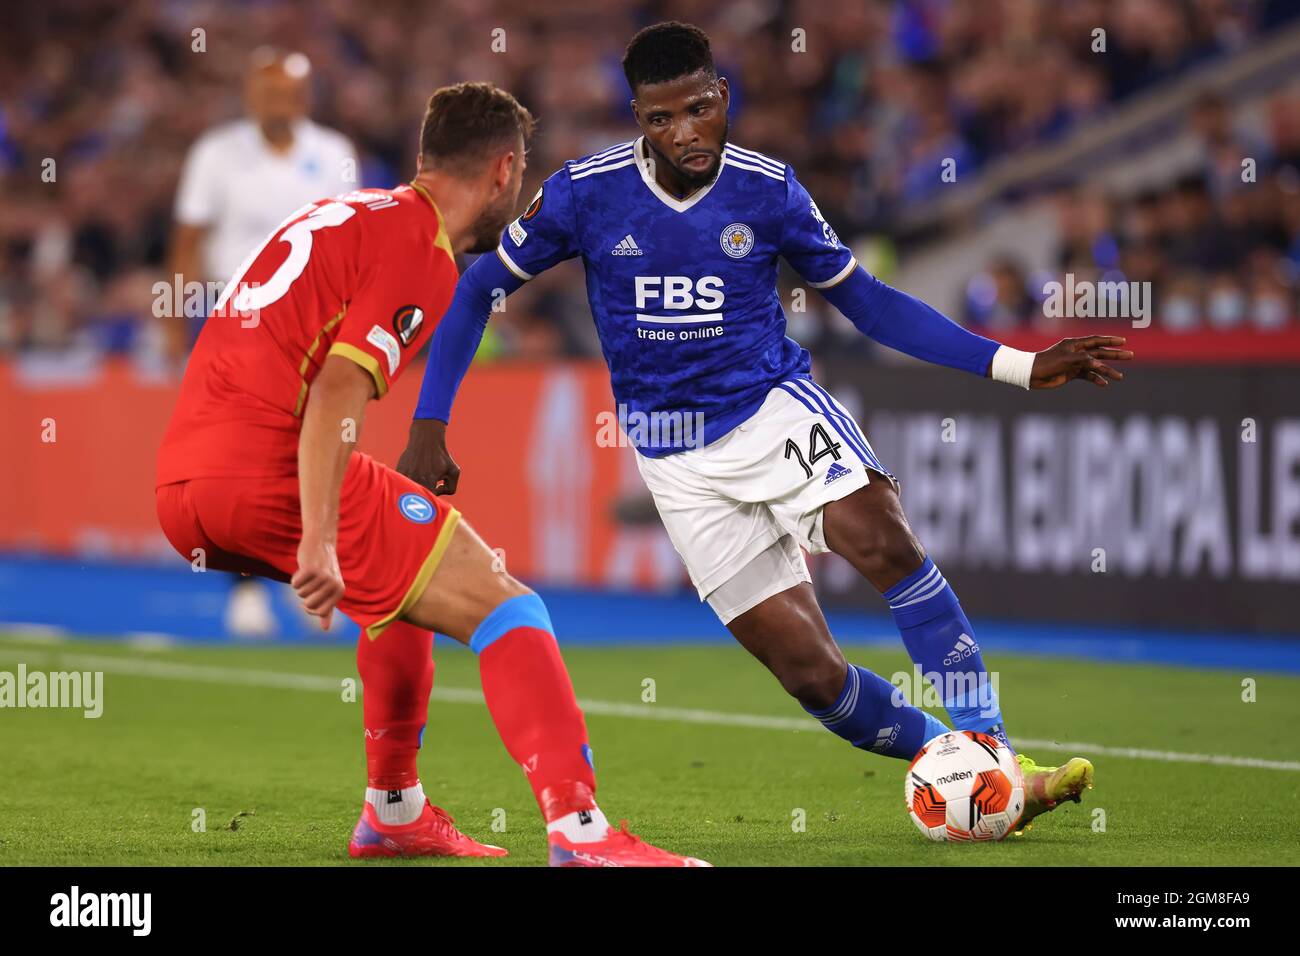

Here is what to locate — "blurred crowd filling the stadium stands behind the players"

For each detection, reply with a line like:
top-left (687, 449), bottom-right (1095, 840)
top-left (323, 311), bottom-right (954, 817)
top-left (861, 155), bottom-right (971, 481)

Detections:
top-left (0, 0), bottom-right (1300, 363)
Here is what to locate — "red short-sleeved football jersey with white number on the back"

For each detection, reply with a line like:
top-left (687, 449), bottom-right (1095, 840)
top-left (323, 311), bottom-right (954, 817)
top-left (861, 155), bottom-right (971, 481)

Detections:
top-left (157, 186), bottom-right (458, 485)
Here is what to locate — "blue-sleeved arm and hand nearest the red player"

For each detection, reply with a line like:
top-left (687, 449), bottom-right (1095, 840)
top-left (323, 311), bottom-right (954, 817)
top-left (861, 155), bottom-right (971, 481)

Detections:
top-left (398, 254), bottom-right (524, 494)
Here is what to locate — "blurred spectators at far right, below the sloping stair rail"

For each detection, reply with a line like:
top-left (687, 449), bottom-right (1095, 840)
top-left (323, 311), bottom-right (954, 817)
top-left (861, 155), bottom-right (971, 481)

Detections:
top-left (967, 83), bottom-right (1300, 332)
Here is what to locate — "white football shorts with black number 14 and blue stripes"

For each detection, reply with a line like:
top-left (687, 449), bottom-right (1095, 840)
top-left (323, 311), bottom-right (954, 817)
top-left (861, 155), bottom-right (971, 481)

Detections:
top-left (637, 378), bottom-right (893, 600)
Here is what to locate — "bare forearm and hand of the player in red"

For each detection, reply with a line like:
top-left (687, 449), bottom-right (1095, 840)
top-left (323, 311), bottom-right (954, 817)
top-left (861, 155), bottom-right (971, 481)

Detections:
top-left (290, 355), bottom-right (374, 631)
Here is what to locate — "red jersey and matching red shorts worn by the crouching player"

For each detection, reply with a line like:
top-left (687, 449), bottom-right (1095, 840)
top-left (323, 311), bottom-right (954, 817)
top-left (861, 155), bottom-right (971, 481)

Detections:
top-left (157, 185), bottom-right (458, 637)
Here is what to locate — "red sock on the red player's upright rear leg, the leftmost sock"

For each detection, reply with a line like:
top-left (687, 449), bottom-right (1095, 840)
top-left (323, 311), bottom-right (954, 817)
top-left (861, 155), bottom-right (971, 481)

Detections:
top-left (356, 620), bottom-right (433, 790)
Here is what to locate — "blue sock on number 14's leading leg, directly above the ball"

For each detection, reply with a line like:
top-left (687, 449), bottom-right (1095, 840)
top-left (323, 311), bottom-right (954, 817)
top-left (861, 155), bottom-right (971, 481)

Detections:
top-left (885, 558), bottom-right (1011, 747)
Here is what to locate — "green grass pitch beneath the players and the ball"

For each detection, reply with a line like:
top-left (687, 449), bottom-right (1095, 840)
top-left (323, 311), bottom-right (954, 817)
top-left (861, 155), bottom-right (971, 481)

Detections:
top-left (0, 637), bottom-right (1300, 866)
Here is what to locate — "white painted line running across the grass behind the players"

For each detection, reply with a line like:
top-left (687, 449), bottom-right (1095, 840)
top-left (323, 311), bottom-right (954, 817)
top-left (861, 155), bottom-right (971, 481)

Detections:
top-left (0, 648), bottom-right (1300, 773)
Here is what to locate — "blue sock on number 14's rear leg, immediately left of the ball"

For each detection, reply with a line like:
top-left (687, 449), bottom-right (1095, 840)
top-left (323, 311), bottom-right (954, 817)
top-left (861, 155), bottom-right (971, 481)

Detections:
top-left (803, 663), bottom-right (948, 760)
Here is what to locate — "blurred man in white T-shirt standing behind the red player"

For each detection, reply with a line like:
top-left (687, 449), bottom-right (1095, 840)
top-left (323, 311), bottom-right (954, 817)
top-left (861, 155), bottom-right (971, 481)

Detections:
top-left (166, 47), bottom-right (359, 360)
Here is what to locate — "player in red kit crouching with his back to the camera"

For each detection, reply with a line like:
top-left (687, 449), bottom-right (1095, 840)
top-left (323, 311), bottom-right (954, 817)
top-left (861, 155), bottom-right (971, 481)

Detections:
top-left (156, 83), bottom-right (707, 866)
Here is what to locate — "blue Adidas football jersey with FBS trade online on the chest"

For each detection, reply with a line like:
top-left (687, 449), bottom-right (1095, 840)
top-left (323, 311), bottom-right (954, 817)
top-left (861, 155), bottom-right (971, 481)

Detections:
top-left (497, 139), bottom-right (857, 457)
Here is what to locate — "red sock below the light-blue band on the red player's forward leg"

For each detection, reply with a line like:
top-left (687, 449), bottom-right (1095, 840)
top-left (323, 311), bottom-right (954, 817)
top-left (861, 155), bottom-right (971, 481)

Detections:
top-left (478, 627), bottom-right (595, 823)
